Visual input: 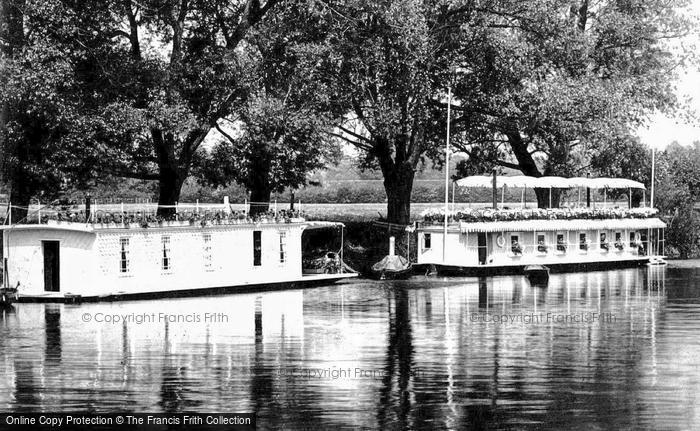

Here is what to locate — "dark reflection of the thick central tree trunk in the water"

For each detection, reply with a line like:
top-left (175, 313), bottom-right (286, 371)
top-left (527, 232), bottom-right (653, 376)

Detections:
top-left (378, 288), bottom-right (413, 429)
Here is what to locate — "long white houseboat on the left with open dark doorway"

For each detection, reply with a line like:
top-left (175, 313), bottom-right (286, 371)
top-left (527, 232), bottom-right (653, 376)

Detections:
top-left (2, 207), bottom-right (356, 301)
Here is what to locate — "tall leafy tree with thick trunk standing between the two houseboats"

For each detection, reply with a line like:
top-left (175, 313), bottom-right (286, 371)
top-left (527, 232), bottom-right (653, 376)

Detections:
top-left (314, 0), bottom-right (480, 224)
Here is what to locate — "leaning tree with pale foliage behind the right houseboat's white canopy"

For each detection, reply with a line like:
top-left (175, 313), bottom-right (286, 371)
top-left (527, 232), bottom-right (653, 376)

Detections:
top-left (453, 0), bottom-right (690, 206)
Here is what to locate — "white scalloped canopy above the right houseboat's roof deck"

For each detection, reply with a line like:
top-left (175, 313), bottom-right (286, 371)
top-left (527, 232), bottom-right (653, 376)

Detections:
top-left (457, 175), bottom-right (646, 189)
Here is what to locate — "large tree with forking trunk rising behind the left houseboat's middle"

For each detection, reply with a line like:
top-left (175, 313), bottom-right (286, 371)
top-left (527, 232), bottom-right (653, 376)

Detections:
top-left (90, 0), bottom-right (278, 216)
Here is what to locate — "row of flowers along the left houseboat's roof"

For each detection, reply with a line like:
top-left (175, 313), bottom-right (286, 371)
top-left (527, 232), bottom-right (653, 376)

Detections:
top-left (41, 210), bottom-right (304, 228)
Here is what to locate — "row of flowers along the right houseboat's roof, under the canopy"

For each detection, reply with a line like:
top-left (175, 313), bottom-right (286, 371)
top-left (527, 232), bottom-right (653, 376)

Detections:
top-left (421, 207), bottom-right (658, 223)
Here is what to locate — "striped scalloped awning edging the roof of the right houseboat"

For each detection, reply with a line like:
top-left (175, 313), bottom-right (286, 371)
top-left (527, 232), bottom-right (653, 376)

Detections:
top-left (459, 218), bottom-right (666, 233)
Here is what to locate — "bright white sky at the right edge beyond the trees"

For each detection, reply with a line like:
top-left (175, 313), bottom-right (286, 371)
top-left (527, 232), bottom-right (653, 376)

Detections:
top-left (637, 0), bottom-right (700, 149)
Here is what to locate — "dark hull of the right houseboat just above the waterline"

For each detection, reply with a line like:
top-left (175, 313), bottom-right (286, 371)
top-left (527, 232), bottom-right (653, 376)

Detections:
top-left (414, 258), bottom-right (649, 277)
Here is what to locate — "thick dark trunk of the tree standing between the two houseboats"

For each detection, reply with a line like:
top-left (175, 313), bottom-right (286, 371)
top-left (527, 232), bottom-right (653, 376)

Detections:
top-left (382, 162), bottom-right (415, 225)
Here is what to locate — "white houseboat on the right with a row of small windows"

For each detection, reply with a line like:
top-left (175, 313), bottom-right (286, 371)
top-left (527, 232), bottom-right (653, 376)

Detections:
top-left (417, 177), bottom-right (666, 272)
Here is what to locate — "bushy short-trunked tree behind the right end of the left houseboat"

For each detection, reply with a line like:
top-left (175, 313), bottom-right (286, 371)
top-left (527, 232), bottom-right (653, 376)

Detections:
top-left (196, 3), bottom-right (339, 213)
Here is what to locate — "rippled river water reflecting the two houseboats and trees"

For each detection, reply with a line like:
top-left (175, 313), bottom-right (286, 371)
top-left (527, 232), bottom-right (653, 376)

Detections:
top-left (0, 267), bottom-right (700, 429)
